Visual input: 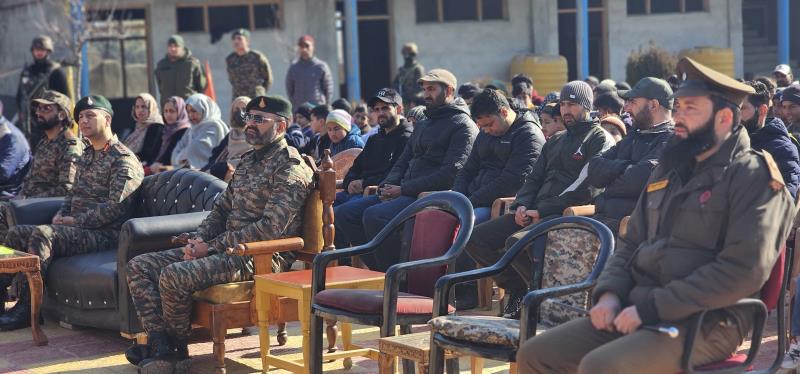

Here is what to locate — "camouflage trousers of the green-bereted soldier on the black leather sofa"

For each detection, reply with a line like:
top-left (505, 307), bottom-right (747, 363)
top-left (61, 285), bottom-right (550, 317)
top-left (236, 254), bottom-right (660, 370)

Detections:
top-left (4, 225), bottom-right (119, 277)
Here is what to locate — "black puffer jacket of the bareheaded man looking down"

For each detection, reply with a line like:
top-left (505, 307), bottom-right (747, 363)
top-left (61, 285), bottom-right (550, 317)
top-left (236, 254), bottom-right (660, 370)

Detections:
top-left (453, 110), bottom-right (545, 208)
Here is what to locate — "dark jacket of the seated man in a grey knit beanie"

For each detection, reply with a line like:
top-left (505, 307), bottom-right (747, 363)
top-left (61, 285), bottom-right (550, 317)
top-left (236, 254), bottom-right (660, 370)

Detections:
top-left (511, 119), bottom-right (613, 218)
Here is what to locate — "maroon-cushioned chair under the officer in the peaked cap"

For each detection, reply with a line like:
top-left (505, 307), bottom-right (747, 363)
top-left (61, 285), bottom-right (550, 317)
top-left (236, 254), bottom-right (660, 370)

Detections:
top-left (681, 246), bottom-right (794, 374)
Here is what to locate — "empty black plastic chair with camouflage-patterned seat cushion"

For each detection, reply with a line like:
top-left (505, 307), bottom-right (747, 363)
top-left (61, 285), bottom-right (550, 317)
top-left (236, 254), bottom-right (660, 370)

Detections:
top-left (428, 216), bottom-right (614, 374)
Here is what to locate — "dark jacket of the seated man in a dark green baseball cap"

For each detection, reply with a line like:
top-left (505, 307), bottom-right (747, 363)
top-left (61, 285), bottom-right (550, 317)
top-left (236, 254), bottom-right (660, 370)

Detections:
top-left (586, 122), bottom-right (673, 219)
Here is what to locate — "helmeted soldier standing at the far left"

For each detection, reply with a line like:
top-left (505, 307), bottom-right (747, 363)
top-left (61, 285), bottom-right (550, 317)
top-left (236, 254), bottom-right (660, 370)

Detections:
top-left (17, 35), bottom-right (69, 150)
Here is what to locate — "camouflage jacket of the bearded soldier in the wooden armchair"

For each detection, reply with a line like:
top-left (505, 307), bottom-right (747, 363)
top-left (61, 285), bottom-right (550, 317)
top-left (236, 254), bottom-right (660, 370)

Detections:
top-left (197, 138), bottom-right (313, 253)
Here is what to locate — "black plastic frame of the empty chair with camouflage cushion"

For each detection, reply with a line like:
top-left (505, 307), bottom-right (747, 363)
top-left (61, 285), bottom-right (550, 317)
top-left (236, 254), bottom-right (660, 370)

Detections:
top-left (429, 216), bottom-right (614, 374)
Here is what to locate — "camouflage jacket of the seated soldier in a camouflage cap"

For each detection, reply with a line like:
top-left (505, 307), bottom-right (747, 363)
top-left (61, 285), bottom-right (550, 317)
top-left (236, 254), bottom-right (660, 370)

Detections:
top-left (22, 129), bottom-right (83, 198)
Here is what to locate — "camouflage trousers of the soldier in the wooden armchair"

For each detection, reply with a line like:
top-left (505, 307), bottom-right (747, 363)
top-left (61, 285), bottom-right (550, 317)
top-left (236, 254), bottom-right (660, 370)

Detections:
top-left (128, 248), bottom-right (253, 338)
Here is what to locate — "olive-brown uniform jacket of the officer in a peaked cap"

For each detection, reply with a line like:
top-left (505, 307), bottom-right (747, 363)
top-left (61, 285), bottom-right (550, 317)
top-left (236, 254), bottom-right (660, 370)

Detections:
top-left (594, 128), bottom-right (795, 329)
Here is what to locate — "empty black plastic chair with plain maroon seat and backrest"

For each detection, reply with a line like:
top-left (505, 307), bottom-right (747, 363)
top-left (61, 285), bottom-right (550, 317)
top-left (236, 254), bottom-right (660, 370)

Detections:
top-left (310, 192), bottom-right (475, 373)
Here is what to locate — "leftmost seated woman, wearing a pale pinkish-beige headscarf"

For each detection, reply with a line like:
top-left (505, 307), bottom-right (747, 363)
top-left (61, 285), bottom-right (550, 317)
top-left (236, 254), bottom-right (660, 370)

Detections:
top-left (123, 93), bottom-right (164, 166)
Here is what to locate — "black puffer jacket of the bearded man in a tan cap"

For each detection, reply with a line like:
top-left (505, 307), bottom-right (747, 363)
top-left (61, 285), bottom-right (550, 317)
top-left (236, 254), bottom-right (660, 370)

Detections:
top-left (383, 100), bottom-right (478, 198)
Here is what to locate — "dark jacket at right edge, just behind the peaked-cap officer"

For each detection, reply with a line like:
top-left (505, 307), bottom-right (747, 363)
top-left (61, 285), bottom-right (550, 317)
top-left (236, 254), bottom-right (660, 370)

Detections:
top-left (750, 118), bottom-right (800, 197)
